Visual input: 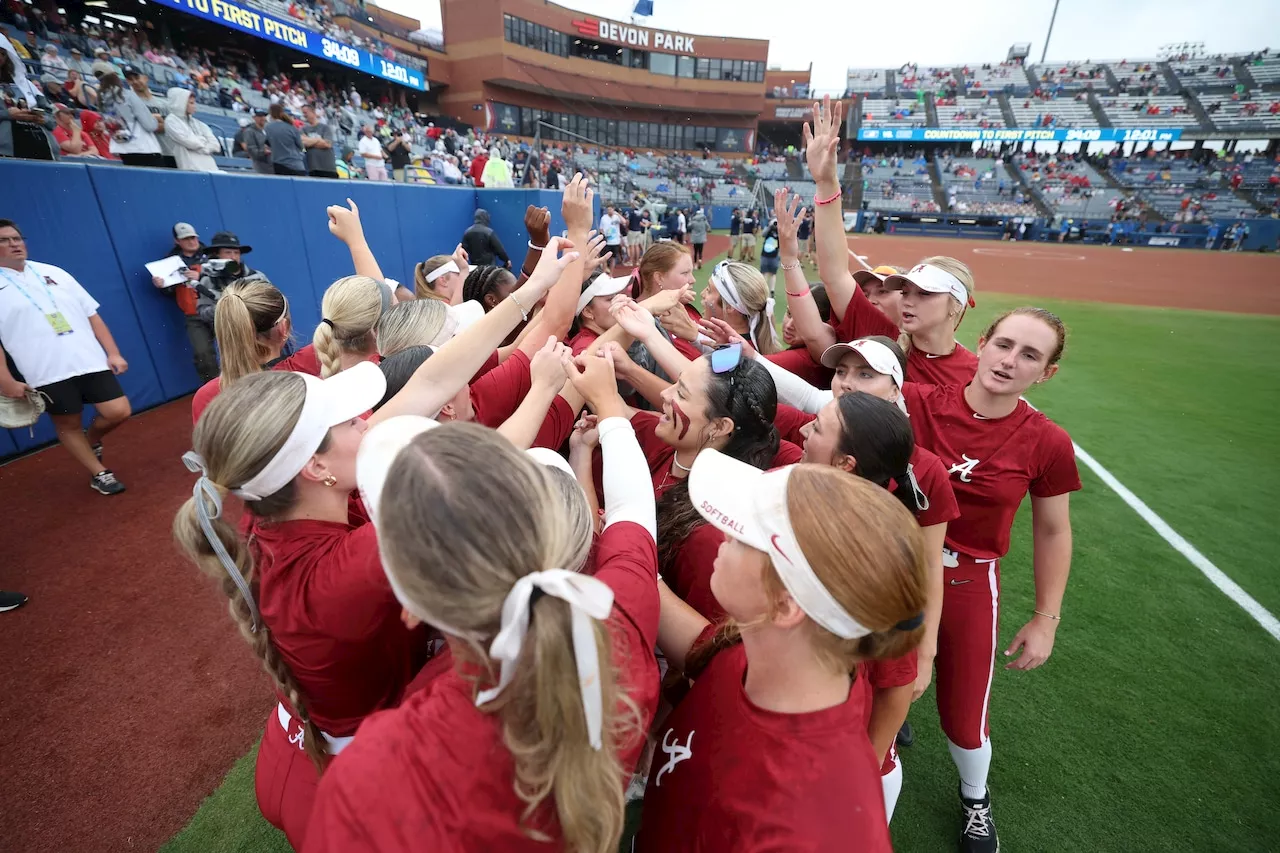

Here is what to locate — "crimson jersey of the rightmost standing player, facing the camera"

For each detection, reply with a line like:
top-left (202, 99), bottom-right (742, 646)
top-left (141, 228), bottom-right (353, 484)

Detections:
top-left (902, 383), bottom-right (1080, 560)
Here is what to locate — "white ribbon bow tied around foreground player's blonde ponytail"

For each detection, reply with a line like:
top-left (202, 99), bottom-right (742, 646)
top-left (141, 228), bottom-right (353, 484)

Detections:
top-left (476, 569), bottom-right (613, 749)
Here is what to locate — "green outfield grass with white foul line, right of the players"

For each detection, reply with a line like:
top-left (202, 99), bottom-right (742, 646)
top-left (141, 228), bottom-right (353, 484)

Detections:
top-left (164, 242), bottom-right (1280, 853)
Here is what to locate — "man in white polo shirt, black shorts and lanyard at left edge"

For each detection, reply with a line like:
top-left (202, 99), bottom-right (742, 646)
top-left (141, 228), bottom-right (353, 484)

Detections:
top-left (0, 219), bottom-right (132, 494)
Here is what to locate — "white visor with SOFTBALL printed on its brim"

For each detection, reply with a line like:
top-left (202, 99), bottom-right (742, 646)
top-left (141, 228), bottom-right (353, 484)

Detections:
top-left (689, 450), bottom-right (872, 639)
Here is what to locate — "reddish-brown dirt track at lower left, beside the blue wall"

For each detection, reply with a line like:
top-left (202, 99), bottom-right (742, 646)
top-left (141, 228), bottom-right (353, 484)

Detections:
top-left (0, 397), bottom-right (271, 853)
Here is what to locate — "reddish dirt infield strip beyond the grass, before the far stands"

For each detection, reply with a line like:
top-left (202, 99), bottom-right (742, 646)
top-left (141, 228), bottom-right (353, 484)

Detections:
top-left (849, 234), bottom-right (1280, 314)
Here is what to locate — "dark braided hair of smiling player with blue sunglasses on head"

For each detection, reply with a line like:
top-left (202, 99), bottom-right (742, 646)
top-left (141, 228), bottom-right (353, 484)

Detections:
top-left (658, 356), bottom-right (781, 578)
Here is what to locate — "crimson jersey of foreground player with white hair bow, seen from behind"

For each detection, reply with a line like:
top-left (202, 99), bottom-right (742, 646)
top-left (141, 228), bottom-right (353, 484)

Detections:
top-left (305, 521), bottom-right (659, 853)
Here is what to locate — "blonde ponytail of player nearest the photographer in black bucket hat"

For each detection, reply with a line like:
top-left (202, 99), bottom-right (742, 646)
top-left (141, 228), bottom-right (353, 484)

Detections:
top-left (214, 280), bottom-right (288, 389)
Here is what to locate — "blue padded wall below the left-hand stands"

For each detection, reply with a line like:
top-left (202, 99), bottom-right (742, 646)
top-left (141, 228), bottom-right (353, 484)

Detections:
top-left (0, 159), bottom-right (599, 450)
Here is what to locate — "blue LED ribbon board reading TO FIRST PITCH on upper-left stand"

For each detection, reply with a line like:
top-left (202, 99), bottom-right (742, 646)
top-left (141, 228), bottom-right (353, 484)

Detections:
top-left (155, 0), bottom-right (428, 91)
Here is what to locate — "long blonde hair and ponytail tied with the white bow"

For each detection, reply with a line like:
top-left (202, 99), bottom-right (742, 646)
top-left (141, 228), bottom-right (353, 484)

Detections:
top-left (379, 423), bottom-right (643, 853)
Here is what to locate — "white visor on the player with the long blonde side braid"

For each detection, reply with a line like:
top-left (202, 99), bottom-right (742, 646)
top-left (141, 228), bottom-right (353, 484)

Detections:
top-left (232, 361), bottom-right (387, 501)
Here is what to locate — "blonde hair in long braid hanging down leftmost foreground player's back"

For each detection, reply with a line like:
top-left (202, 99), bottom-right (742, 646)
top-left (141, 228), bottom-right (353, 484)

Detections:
top-left (173, 371), bottom-right (328, 770)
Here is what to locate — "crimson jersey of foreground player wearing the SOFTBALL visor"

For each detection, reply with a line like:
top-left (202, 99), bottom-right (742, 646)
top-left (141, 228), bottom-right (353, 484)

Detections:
top-left (637, 646), bottom-right (892, 853)
